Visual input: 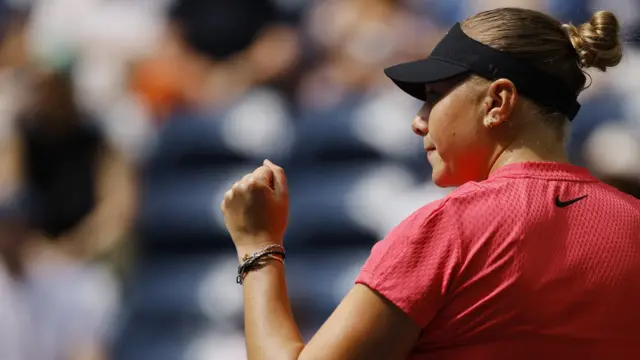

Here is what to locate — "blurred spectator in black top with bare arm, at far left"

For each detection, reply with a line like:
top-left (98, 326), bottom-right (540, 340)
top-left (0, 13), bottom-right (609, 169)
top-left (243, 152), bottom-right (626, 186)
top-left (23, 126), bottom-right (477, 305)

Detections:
top-left (16, 69), bottom-right (135, 259)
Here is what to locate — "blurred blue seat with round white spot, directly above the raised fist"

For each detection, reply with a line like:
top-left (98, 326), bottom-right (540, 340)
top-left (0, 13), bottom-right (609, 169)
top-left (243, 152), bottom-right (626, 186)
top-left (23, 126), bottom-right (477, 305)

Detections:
top-left (148, 88), bottom-right (295, 176)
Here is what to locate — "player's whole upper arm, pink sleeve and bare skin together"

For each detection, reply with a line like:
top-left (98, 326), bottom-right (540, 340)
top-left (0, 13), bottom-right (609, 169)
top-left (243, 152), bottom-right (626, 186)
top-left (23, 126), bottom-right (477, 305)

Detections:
top-left (300, 201), bottom-right (461, 360)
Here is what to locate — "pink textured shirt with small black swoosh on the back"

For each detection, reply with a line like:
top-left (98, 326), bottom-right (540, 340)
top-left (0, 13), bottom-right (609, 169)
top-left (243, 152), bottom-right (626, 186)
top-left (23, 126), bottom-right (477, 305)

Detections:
top-left (356, 163), bottom-right (640, 360)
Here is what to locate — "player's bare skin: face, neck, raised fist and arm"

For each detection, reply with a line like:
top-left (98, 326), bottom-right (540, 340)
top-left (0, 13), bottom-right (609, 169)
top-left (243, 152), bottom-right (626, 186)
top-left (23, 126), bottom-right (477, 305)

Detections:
top-left (221, 74), bottom-right (567, 360)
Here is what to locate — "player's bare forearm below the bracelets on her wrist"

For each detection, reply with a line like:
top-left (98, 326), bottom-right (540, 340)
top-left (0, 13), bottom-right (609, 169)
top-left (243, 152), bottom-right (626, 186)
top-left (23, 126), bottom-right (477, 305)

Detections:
top-left (239, 245), bottom-right (304, 360)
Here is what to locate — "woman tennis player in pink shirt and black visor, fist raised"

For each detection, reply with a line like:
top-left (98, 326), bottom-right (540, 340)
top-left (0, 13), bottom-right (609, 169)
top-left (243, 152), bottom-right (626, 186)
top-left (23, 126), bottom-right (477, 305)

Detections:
top-left (222, 8), bottom-right (640, 360)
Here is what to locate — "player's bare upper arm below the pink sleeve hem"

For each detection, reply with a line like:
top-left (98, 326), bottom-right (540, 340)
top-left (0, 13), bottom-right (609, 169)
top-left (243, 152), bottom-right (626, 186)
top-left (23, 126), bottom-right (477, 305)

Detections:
top-left (299, 284), bottom-right (420, 360)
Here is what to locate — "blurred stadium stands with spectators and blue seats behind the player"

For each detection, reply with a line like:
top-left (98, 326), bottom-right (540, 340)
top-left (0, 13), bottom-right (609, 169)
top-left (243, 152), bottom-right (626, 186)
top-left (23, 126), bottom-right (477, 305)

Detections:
top-left (0, 0), bottom-right (640, 360)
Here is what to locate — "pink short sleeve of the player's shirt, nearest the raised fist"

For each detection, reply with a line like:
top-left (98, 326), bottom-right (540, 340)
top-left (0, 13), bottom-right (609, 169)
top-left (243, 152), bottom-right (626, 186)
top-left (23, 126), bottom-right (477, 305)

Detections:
top-left (356, 198), bottom-right (460, 328)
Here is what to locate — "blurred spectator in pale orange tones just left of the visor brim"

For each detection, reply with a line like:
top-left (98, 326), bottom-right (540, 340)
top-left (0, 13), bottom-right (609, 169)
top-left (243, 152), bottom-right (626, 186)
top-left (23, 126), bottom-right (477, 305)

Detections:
top-left (298, 0), bottom-right (441, 109)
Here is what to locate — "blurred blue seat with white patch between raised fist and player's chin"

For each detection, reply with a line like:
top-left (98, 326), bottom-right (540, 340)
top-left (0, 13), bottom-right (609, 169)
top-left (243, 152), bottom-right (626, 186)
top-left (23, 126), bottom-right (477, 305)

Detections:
top-left (285, 161), bottom-right (416, 249)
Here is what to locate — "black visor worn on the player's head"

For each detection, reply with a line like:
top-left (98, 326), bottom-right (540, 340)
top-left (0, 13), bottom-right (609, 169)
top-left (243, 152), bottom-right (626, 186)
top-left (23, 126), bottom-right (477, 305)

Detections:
top-left (385, 23), bottom-right (580, 120)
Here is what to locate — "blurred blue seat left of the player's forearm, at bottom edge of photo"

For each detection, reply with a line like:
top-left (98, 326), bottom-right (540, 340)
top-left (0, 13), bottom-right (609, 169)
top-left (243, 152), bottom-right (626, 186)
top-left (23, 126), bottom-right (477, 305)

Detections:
top-left (113, 252), bottom-right (242, 360)
